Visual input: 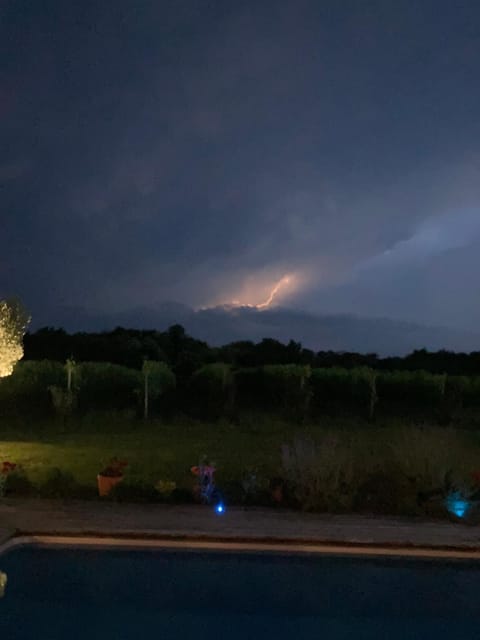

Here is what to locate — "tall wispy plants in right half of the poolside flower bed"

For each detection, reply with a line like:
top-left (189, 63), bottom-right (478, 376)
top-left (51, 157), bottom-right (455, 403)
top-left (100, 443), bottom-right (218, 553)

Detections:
top-left (282, 426), bottom-right (480, 514)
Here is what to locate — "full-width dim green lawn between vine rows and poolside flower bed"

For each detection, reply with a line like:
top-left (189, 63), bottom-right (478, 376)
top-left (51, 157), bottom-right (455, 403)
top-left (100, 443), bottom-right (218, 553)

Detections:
top-left (0, 415), bottom-right (480, 502)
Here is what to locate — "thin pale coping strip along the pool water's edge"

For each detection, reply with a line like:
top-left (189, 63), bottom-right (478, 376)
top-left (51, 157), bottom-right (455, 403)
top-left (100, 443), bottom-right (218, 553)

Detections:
top-left (0, 535), bottom-right (480, 560)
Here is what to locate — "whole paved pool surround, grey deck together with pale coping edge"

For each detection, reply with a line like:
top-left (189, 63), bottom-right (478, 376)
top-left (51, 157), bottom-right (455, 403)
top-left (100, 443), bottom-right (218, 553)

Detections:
top-left (0, 499), bottom-right (480, 558)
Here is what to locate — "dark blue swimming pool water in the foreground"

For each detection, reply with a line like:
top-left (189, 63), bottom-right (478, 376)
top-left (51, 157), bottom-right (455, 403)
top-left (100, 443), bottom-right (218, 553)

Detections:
top-left (0, 547), bottom-right (480, 640)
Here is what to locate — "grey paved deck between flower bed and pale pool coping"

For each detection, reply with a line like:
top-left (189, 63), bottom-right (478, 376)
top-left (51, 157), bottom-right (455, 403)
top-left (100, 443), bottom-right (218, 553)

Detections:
top-left (0, 499), bottom-right (480, 551)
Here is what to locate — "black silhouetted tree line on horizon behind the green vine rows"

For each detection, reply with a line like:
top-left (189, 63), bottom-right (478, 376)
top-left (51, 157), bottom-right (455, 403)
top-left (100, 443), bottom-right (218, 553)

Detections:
top-left (24, 324), bottom-right (480, 379)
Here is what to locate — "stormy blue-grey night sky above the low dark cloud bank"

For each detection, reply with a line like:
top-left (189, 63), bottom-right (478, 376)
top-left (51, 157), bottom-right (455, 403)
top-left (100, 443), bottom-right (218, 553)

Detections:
top-left (0, 0), bottom-right (480, 330)
